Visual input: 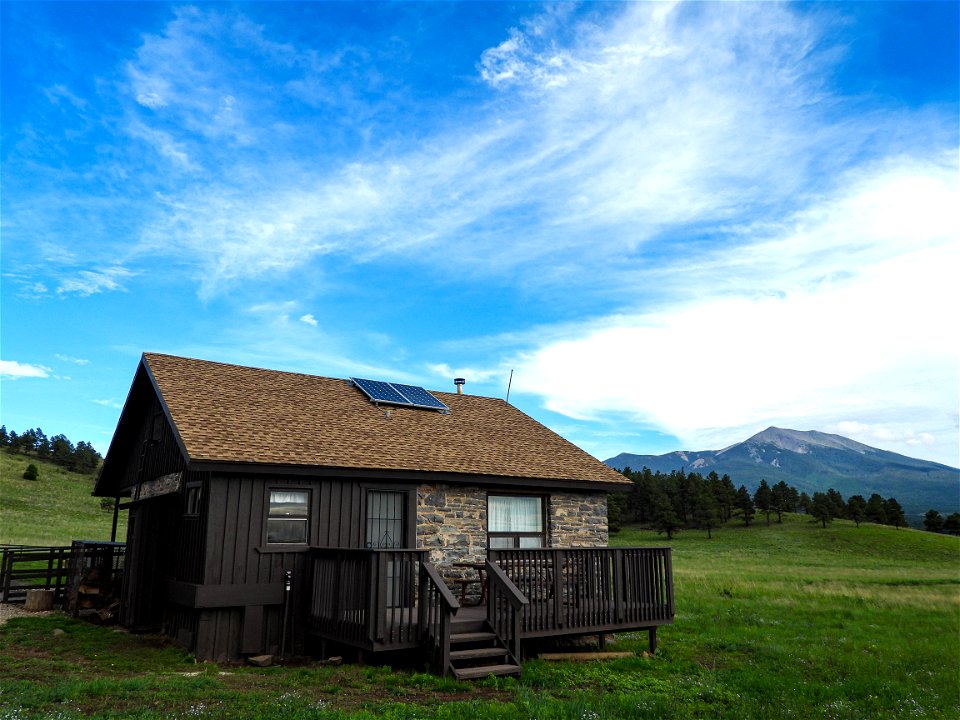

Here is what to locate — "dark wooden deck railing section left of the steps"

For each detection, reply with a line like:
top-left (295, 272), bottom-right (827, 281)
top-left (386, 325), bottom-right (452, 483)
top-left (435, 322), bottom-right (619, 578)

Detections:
top-left (309, 548), bottom-right (427, 649)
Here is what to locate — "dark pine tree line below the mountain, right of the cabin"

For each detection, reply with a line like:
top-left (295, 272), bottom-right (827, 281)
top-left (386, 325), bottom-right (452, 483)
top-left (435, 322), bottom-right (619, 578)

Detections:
top-left (609, 467), bottom-right (960, 539)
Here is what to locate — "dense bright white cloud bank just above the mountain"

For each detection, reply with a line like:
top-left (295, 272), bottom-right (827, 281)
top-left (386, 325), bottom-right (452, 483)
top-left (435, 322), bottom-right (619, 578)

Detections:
top-left (520, 155), bottom-right (960, 462)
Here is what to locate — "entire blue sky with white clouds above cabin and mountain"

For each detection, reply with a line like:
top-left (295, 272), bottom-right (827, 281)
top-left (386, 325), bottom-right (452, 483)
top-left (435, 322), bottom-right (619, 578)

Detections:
top-left (0, 2), bottom-right (960, 466)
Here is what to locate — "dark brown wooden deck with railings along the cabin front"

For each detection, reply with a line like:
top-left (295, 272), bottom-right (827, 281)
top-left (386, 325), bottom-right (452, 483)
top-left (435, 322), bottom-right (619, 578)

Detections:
top-left (308, 548), bottom-right (674, 672)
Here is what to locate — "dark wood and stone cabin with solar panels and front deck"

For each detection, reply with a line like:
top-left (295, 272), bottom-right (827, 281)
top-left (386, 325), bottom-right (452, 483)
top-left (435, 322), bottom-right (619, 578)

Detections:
top-left (94, 354), bottom-right (674, 678)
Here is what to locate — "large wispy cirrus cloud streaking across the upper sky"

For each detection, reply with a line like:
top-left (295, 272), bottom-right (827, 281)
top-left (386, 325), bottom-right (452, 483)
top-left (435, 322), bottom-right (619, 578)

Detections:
top-left (114, 4), bottom-right (944, 297)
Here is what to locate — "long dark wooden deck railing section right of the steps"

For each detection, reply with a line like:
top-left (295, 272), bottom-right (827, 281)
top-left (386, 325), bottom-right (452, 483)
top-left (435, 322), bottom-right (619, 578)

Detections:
top-left (489, 547), bottom-right (674, 635)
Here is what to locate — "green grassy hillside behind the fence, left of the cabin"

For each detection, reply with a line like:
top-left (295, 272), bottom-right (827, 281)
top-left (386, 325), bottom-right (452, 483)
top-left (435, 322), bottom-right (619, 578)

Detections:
top-left (0, 452), bottom-right (126, 545)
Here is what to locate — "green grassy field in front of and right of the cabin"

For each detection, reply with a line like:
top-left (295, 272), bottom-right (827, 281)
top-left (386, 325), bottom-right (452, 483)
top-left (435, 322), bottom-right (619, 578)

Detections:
top-left (0, 516), bottom-right (960, 720)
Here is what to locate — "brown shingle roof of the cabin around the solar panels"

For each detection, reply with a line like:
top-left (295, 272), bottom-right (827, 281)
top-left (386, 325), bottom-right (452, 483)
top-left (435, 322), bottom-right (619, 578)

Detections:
top-left (144, 354), bottom-right (628, 483)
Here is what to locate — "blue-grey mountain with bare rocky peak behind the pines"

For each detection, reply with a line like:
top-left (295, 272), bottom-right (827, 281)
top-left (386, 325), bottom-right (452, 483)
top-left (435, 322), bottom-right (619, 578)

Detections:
top-left (604, 427), bottom-right (960, 516)
